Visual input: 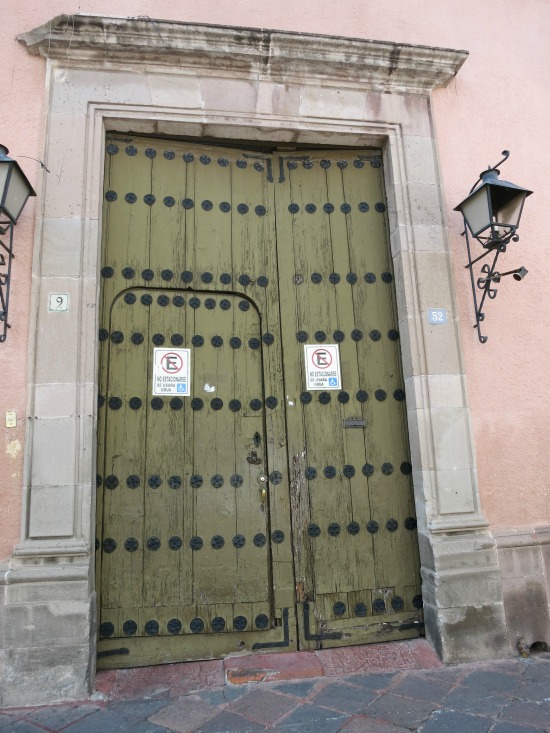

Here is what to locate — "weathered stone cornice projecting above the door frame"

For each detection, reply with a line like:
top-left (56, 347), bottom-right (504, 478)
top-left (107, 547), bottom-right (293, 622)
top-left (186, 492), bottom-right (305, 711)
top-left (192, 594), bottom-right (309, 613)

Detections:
top-left (18, 14), bottom-right (468, 94)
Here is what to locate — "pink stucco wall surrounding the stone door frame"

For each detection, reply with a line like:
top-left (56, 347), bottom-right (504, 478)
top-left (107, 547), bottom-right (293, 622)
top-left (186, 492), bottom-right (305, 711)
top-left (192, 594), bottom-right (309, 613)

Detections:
top-left (0, 0), bottom-right (550, 560)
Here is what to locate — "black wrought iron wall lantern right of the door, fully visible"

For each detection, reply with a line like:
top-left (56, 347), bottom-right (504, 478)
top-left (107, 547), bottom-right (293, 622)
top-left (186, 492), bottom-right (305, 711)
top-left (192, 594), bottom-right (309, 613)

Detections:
top-left (454, 150), bottom-right (533, 344)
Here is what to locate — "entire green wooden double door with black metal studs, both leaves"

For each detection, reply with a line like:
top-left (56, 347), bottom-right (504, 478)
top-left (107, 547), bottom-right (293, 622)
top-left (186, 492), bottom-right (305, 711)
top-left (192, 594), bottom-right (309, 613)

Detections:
top-left (96, 137), bottom-right (421, 667)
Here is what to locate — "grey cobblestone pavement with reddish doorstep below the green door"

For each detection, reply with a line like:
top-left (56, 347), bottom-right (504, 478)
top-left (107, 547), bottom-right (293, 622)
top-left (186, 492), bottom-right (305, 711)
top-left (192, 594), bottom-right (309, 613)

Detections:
top-left (0, 640), bottom-right (550, 733)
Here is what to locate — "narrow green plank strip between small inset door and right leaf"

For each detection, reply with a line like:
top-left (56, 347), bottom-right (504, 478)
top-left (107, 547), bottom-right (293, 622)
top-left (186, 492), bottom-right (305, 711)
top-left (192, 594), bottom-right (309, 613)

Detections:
top-left (232, 153), bottom-right (293, 605)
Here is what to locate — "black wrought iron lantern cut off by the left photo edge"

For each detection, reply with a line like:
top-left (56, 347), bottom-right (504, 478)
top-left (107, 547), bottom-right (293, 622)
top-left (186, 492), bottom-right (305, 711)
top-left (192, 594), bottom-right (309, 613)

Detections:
top-left (0, 145), bottom-right (36, 343)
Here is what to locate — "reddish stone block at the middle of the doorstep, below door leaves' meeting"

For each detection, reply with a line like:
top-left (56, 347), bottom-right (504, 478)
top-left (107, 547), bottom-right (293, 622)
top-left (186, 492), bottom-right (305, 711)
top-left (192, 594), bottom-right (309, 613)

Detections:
top-left (223, 652), bottom-right (323, 685)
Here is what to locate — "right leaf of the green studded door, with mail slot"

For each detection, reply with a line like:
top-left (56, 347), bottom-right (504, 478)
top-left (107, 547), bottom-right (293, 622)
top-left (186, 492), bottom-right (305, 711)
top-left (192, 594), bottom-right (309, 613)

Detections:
top-left (277, 150), bottom-right (422, 648)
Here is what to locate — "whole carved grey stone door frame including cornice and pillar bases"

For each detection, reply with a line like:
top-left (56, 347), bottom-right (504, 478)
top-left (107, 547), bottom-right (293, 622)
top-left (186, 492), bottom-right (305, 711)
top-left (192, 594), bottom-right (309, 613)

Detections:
top-left (2, 15), bottom-right (508, 705)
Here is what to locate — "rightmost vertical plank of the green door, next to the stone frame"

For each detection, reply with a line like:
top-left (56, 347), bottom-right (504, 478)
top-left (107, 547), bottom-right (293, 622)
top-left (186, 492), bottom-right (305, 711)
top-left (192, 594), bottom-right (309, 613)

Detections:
top-left (344, 157), bottom-right (418, 608)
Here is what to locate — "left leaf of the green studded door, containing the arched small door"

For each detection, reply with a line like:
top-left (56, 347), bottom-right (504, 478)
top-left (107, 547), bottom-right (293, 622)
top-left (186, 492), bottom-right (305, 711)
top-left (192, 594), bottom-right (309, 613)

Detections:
top-left (96, 140), bottom-right (296, 667)
